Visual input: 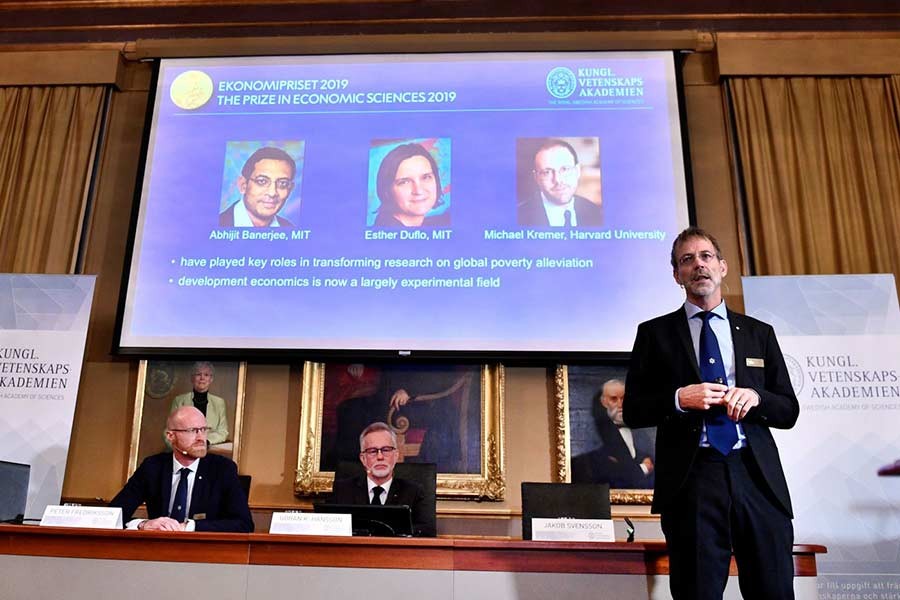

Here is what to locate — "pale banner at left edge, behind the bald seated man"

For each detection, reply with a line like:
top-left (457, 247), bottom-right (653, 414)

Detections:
top-left (0, 274), bottom-right (95, 519)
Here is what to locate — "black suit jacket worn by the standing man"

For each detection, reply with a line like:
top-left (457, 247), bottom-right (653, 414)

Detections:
top-left (623, 307), bottom-right (800, 517)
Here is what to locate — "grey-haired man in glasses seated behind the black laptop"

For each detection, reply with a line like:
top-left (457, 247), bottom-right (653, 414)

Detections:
top-left (330, 422), bottom-right (437, 537)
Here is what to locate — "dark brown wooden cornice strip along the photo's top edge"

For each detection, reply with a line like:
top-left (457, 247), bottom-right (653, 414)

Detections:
top-left (0, 0), bottom-right (900, 43)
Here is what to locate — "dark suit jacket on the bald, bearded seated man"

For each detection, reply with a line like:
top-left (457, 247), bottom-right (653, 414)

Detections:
top-left (109, 452), bottom-right (253, 533)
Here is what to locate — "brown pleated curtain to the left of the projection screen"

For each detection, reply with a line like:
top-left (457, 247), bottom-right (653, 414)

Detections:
top-left (0, 86), bottom-right (105, 273)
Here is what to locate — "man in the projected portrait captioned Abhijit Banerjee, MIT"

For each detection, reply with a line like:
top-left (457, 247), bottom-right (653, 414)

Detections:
top-left (219, 147), bottom-right (297, 227)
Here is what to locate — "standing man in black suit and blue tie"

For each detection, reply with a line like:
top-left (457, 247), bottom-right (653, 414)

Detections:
top-left (623, 227), bottom-right (800, 600)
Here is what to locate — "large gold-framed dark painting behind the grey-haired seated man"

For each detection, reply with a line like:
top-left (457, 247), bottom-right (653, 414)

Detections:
top-left (294, 362), bottom-right (506, 500)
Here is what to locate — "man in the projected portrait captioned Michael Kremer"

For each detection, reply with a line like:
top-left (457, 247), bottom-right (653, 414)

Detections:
top-left (518, 138), bottom-right (603, 227)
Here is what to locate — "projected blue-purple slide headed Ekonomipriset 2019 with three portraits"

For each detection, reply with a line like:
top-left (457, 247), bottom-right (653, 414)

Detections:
top-left (119, 52), bottom-right (688, 356)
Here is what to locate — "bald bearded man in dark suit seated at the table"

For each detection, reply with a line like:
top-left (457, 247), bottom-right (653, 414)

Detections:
top-left (109, 406), bottom-right (253, 532)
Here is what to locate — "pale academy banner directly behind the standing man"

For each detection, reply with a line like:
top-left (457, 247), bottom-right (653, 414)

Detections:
top-left (743, 275), bottom-right (900, 600)
